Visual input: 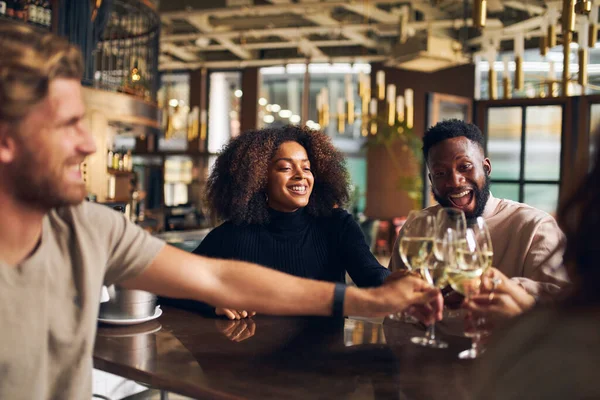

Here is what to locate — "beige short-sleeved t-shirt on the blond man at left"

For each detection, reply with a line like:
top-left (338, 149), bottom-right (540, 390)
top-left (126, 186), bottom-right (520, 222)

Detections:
top-left (0, 202), bottom-right (164, 400)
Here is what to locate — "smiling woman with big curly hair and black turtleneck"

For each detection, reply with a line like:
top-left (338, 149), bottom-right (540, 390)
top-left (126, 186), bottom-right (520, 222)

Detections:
top-left (162, 126), bottom-right (389, 319)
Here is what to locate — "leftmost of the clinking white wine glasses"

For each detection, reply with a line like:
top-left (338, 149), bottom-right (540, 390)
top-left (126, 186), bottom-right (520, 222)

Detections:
top-left (389, 210), bottom-right (435, 323)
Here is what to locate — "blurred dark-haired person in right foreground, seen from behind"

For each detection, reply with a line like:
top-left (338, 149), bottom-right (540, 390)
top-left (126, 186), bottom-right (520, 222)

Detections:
top-left (473, 136), bottom-right (600, 400)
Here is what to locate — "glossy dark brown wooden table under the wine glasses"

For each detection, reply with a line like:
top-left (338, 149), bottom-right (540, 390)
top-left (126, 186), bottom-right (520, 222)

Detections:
top-left (94, 307), bottom-right (474, 399)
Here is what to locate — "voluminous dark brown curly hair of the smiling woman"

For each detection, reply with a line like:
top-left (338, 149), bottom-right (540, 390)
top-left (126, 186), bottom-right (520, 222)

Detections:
top-left (206, 126), bottom-right (349, 224)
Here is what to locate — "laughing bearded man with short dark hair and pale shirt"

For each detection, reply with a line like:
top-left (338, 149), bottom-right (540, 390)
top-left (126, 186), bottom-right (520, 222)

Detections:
top-left (390, 119), bottom-right (567, 298)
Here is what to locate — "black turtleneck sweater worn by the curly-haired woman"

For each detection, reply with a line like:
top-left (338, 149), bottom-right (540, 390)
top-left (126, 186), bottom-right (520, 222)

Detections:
top-left (159, 209), bottom-right (390, 311)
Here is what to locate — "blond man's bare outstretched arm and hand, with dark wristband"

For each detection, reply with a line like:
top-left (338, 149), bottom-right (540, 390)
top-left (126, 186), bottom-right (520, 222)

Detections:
top-left (121, 242), bottom-right (440, 318)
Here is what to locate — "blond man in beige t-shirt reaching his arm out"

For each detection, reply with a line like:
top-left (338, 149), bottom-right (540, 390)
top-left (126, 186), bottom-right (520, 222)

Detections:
top-left (0, 23), bottom-right (441, 400)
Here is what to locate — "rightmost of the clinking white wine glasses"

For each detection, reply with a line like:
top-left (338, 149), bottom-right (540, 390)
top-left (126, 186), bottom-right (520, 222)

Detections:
top-left (447, 228), bottom-right (488, 359)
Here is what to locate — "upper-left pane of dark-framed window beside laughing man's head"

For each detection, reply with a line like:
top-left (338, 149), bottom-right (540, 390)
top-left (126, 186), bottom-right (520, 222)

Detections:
top-left (487, 107), bottom-right (523, 179)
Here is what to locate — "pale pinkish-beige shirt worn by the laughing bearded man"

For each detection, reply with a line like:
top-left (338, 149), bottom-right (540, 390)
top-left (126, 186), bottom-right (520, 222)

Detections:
top-left (390, 194), bottom-right (568, 300)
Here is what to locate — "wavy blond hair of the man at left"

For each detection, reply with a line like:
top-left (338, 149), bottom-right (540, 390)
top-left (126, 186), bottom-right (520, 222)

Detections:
top-left (0, 22), bottom-right (83, 122)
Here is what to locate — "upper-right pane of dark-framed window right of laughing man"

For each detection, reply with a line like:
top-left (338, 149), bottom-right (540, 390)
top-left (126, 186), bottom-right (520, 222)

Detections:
top-left (525, 106), bottom-right (562, 180)
